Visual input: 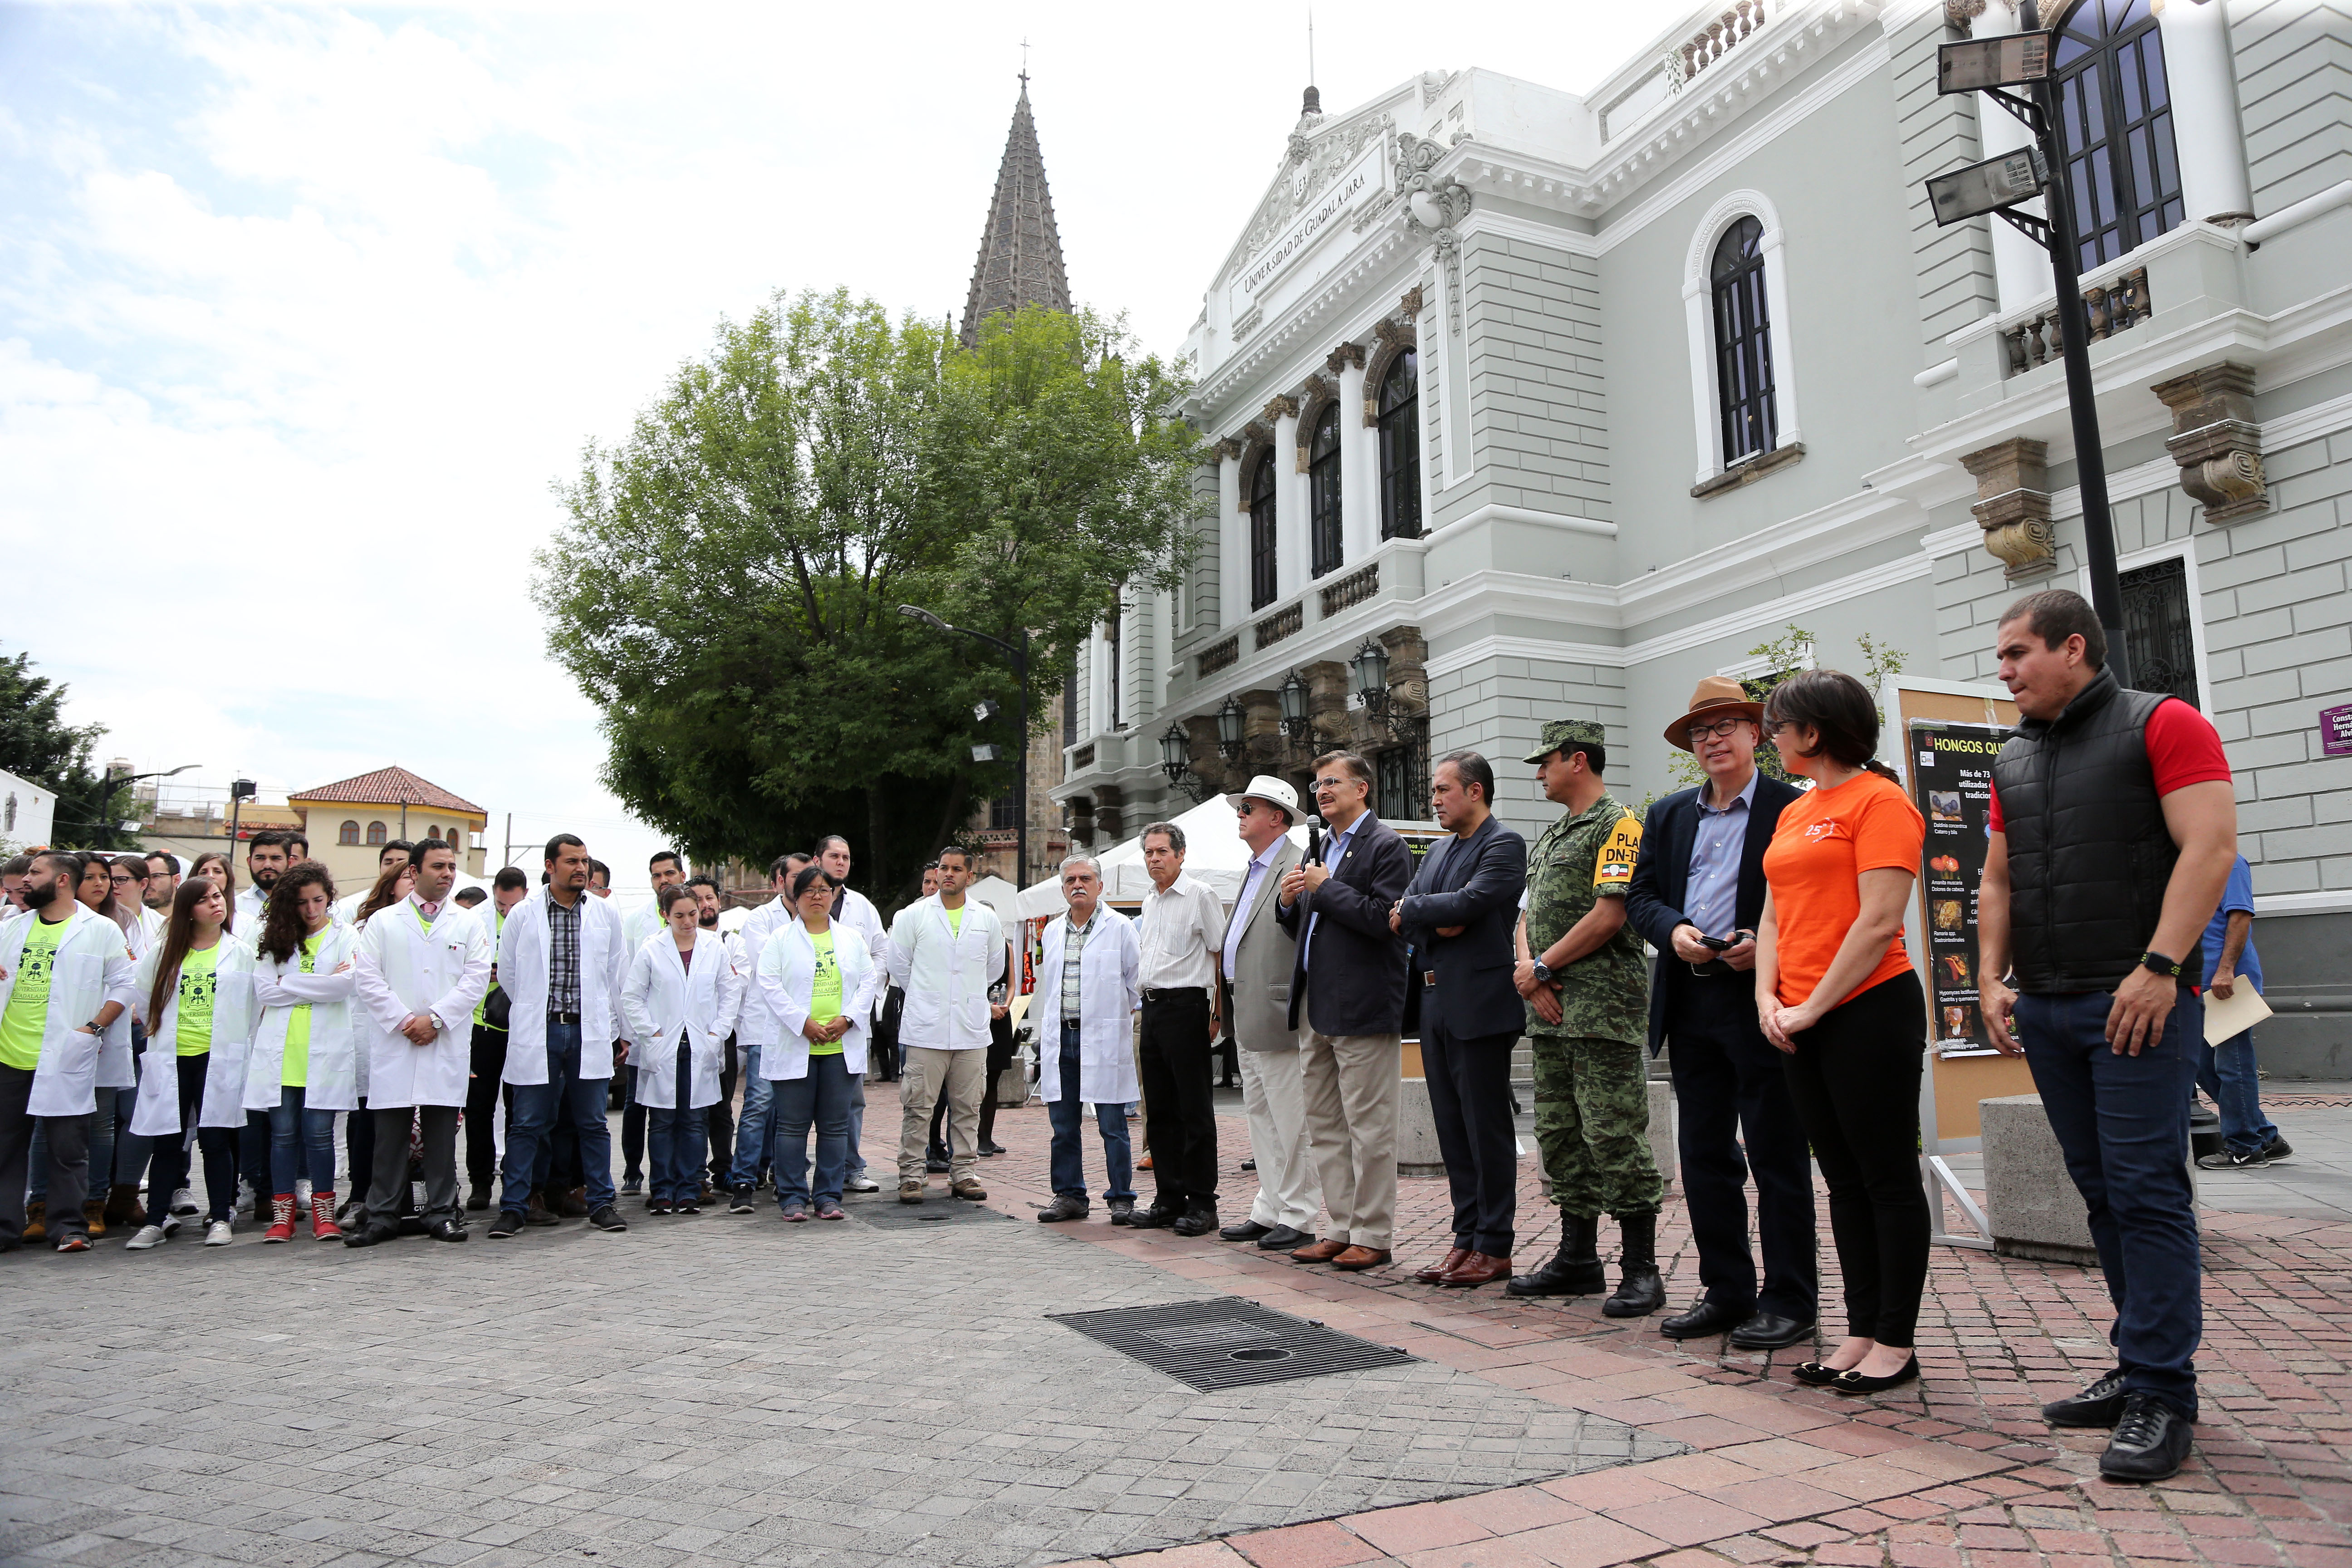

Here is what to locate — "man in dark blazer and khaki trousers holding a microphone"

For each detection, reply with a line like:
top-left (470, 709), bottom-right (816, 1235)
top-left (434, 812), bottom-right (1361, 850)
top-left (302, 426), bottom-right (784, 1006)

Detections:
top-left (1275, 752), bottom-right (1414, 1269)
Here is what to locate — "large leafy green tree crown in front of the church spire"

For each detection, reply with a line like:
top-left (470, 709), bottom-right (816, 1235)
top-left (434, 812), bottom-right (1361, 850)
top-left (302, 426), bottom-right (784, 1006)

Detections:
top-left (534, 291), bottom-right (1197, 893)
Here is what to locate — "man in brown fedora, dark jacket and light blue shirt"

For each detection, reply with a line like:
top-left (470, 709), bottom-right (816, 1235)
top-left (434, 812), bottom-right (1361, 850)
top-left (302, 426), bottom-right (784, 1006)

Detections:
top-left (1625, 675), bottom-right (1818, 1349)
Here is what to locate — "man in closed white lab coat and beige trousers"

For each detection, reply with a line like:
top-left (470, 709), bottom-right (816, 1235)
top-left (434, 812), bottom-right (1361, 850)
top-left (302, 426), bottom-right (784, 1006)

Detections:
top-left (889, 844), bottom-right (1004, 1204)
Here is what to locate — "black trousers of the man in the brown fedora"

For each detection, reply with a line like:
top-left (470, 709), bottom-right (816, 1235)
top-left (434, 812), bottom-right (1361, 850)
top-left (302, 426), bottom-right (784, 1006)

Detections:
top-left (1665, 964), bottom-right (1820, 1323)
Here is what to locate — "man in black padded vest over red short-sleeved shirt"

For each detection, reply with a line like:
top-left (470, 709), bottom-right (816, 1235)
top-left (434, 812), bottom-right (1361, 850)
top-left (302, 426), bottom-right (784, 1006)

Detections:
top-left (1976, 590), bottom-right (2237, 1481)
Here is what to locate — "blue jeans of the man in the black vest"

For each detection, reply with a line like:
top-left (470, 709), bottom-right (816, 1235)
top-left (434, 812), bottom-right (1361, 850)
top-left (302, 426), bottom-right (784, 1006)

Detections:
top-left (2016, 990), bottom-right (2204, 1420)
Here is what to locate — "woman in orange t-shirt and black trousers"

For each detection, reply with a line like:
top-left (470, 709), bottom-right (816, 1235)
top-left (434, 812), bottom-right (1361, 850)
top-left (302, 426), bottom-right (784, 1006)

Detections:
top-left (1757, 670), bottom-right (1931, 1394)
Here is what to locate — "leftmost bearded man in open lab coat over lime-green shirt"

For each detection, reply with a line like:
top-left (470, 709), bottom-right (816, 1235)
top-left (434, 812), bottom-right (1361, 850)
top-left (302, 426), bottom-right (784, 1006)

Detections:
top-left (0, 851), bottom-right (137, 1253)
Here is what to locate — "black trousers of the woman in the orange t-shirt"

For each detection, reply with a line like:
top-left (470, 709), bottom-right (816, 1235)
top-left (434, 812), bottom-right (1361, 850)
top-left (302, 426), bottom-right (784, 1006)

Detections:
top-left (1780, 971), bottom-right (1929, 1347)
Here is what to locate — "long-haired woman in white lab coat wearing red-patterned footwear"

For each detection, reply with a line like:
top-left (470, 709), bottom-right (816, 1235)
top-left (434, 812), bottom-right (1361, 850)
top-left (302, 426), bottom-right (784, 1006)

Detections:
top-left (245, 860), bottom-right (367, 1241)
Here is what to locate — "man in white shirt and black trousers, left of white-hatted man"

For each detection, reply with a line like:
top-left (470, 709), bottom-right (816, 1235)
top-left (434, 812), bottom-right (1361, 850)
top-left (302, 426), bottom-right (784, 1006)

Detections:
top-left (1132, 823), bottom-right (1225, 1236)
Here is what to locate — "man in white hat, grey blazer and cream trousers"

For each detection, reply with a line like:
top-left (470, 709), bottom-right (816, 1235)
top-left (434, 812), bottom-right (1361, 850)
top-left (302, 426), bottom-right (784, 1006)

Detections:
top-left (1216, 774), bottom-right (1322, 1253)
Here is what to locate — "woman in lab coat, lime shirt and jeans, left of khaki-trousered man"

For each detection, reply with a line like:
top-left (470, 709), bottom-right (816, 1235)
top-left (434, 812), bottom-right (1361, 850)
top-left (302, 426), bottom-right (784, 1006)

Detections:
top-left (757, 865), bottom-right (882, 1220)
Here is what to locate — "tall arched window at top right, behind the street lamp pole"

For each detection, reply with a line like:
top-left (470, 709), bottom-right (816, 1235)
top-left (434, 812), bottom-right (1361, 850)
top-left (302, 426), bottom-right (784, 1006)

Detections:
top-left (2051, 0), bottom-right (2183, 270)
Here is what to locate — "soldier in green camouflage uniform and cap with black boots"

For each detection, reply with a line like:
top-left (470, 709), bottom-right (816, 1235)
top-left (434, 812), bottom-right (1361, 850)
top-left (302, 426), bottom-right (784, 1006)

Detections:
top-left (1508, 720), bottom-right (1665, 1317)
